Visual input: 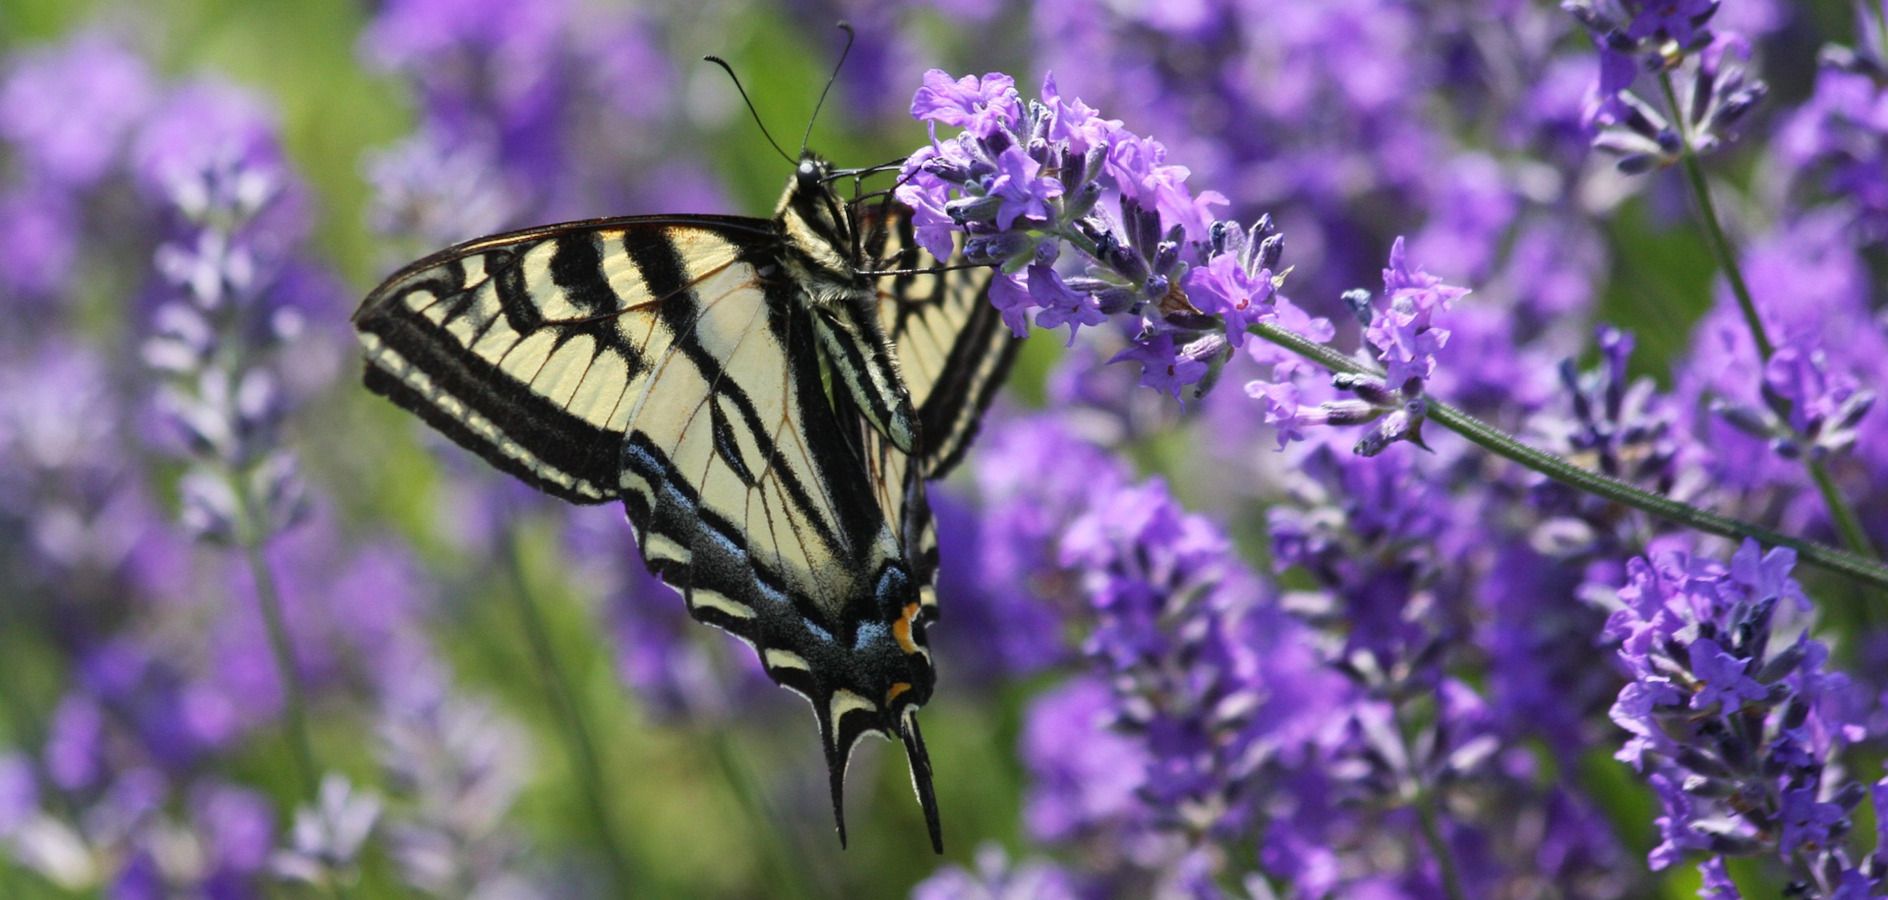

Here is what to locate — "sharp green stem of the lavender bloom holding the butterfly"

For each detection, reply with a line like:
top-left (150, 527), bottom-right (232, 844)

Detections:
top-left (1250, 325), bottom-right (1888, 589)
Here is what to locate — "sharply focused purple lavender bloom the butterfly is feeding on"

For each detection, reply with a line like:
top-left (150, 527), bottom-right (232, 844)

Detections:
top-left (897, 72), bottom-right (1238, 379)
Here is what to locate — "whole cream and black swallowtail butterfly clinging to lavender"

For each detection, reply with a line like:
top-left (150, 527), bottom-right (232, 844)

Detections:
top-left (353, 151), bottom-right (1018, 853)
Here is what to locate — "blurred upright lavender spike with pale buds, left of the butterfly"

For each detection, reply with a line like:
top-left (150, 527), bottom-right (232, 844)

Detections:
top-left (138, 87), bottom-right (328, 542)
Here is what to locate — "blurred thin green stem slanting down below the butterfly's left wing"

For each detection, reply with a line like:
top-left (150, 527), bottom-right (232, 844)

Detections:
top-left (504, 528), bottom-right (634, 896)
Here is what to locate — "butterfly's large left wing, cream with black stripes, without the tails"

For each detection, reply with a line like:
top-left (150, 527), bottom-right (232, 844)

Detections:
top-left (355, 217), bottom-right (910, 630)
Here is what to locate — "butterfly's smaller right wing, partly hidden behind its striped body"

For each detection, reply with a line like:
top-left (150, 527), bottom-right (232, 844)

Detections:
top-left (865, 204), bottom-right (1020, 479)
